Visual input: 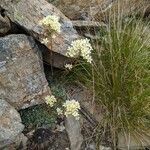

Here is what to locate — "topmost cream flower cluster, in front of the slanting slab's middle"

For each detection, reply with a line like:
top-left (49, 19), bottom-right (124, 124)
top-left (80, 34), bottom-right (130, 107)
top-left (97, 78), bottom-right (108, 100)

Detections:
top-left (40, 15), bottom-right (61, 33)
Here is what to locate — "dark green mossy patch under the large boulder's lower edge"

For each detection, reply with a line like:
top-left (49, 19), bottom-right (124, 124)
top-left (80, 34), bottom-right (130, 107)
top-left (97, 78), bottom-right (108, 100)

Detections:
top-left (19, 104), bottom-right (57, 128)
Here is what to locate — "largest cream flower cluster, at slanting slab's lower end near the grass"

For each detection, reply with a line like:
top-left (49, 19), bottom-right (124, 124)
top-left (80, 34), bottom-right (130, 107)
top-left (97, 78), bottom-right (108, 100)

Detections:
top-left (67, 39), bottom-right (93, 63)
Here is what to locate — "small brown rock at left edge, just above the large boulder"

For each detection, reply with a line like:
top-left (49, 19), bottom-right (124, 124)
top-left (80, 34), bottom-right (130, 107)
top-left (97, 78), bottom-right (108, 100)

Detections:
top-left (0, 15), bottom-right (11, 35)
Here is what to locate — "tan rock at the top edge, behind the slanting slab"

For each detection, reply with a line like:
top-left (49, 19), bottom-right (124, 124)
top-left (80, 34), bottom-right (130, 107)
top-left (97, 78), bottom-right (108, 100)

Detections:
top-left (48, 0), bottom-right (113, 21)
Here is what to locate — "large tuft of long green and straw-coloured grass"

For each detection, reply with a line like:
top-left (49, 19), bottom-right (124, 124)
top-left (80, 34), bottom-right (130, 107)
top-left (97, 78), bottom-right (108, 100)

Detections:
top-left (68, 13), bottom-right (150, 149)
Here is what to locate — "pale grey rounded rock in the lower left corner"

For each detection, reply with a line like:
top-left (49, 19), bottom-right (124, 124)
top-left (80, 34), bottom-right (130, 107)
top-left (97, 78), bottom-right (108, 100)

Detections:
top-left (0, 99), bottom-right (24, 149)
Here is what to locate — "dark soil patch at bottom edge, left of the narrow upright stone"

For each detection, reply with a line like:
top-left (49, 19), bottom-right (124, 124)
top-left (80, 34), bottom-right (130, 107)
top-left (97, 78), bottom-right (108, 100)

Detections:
top-left (27, 128), bottom-right (70, 150)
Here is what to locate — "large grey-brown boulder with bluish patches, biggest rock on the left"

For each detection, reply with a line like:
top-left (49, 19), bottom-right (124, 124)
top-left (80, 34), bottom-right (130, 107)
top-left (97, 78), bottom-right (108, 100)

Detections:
top-left (0, 34), bottom-right (50, 109)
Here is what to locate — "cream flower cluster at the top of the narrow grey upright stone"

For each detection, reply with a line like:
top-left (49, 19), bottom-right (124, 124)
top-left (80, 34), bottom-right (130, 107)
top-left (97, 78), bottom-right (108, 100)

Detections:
top-left (63, 99), bottom-right (80, 120)
